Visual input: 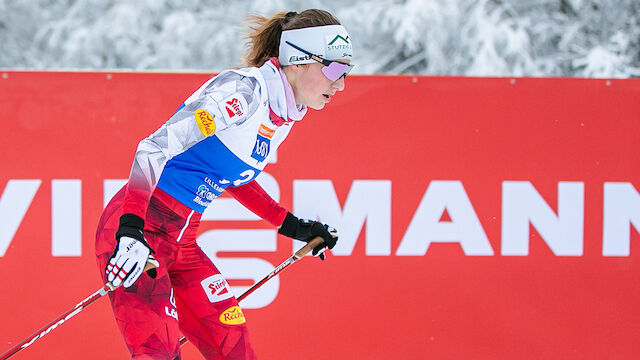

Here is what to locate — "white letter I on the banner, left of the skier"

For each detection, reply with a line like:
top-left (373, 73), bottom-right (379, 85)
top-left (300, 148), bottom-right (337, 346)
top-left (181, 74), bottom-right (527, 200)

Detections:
top-left (51, 179), bottom-right (82, 256)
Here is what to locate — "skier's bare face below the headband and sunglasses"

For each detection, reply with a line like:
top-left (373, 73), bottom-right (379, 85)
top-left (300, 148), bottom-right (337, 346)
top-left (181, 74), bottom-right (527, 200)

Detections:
top-left (285, 60), bottom-right (348, 110)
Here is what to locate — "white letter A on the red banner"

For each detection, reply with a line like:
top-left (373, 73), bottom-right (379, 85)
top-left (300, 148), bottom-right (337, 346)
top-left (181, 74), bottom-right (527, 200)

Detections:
top-left (396, 181), bottom-right (493, 256)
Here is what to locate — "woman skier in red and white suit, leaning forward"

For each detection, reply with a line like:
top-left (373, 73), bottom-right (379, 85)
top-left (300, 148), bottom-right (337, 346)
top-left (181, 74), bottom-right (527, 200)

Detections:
top-left (96, 9), bottom-right (352, 359)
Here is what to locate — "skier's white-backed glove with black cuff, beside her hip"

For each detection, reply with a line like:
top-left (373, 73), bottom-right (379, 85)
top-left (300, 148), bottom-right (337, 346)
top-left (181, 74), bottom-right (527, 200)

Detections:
top-left (105, 214), bottom-right (155, 287)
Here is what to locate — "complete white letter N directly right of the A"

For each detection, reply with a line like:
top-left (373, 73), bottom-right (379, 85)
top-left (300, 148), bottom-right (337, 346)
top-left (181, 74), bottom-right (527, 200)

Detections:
top-left (501, 181), bottom-right (584, 256)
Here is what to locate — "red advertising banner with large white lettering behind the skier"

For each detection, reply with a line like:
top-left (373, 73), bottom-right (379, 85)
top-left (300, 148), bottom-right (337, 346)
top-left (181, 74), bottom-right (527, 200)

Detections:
top-left (0, 72), bottom-right (640, 359)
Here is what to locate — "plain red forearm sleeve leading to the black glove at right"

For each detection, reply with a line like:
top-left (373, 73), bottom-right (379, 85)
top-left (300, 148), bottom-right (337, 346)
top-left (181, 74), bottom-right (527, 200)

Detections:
top-left (226, 180), bottom-right (288, 227)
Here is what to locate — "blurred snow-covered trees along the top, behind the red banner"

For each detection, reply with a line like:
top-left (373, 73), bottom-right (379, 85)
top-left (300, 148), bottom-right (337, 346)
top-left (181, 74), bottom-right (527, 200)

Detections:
top-left (0, 0), bottom-right (640, 78)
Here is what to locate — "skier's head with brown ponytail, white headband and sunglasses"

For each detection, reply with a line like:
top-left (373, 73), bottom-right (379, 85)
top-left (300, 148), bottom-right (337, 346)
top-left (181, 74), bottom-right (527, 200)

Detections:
top-left (245, 9), bottom-right (353, 110)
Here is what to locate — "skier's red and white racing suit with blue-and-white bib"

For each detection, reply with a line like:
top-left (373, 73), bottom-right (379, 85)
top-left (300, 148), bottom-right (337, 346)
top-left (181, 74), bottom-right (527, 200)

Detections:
top-left (96, 59), bottom-right (306, 359)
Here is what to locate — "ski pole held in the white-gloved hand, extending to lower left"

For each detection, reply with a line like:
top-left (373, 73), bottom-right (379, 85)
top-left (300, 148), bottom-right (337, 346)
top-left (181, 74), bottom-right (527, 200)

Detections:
top-left (0, 256), bottom-right (159, 360)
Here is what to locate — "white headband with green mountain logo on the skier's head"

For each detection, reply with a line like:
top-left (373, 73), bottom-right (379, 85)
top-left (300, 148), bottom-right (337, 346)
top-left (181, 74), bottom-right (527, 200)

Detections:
top-left (278, 25), bottom-right (353, 66)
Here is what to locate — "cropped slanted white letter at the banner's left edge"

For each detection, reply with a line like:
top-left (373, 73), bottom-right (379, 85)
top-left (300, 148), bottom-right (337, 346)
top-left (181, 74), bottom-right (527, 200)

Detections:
top-left (0, 179), bottom-right (42, 257)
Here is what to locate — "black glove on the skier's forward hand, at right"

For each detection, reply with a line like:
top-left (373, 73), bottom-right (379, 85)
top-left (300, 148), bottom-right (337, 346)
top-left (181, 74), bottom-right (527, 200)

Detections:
top-left (278, 212), bottom-right (338, 260)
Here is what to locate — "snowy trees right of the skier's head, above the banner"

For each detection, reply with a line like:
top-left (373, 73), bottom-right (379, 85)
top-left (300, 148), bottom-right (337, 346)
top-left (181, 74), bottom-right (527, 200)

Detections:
top-left (341, 0), bottom-right (640, 77)
